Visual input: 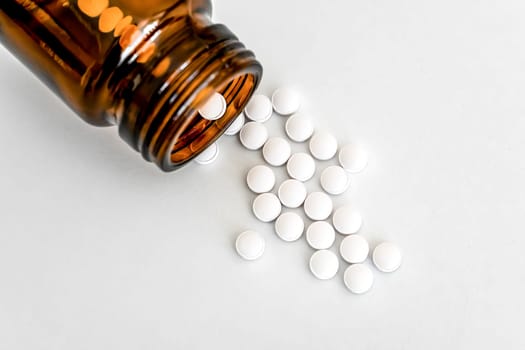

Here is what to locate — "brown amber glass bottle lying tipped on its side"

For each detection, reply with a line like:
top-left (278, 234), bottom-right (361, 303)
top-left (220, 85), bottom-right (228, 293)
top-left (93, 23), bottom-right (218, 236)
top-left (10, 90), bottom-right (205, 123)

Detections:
top-left (0, 0), bottom-right (262, 171)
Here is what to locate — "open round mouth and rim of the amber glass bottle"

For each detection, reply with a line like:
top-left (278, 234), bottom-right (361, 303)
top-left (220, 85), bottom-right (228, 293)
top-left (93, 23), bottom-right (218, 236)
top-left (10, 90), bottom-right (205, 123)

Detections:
top-left (146, 42), bottom-right (262, 171)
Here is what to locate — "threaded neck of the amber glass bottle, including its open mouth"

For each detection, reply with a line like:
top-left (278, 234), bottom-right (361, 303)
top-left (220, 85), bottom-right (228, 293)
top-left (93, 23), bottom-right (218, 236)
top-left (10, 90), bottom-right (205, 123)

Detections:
top-left (107, 10), bottom-right (262, 171)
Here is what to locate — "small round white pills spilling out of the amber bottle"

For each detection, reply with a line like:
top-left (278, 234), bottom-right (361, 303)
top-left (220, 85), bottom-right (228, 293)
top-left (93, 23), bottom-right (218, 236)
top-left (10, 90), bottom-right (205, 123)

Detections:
top-left (195, 87), bottom-right (402, 294)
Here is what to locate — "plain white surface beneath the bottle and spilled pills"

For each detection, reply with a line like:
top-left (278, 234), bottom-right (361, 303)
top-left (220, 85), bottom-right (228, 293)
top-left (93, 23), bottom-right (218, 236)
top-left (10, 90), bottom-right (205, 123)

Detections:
top-left (0, 0), bottom-right (525, 350)
